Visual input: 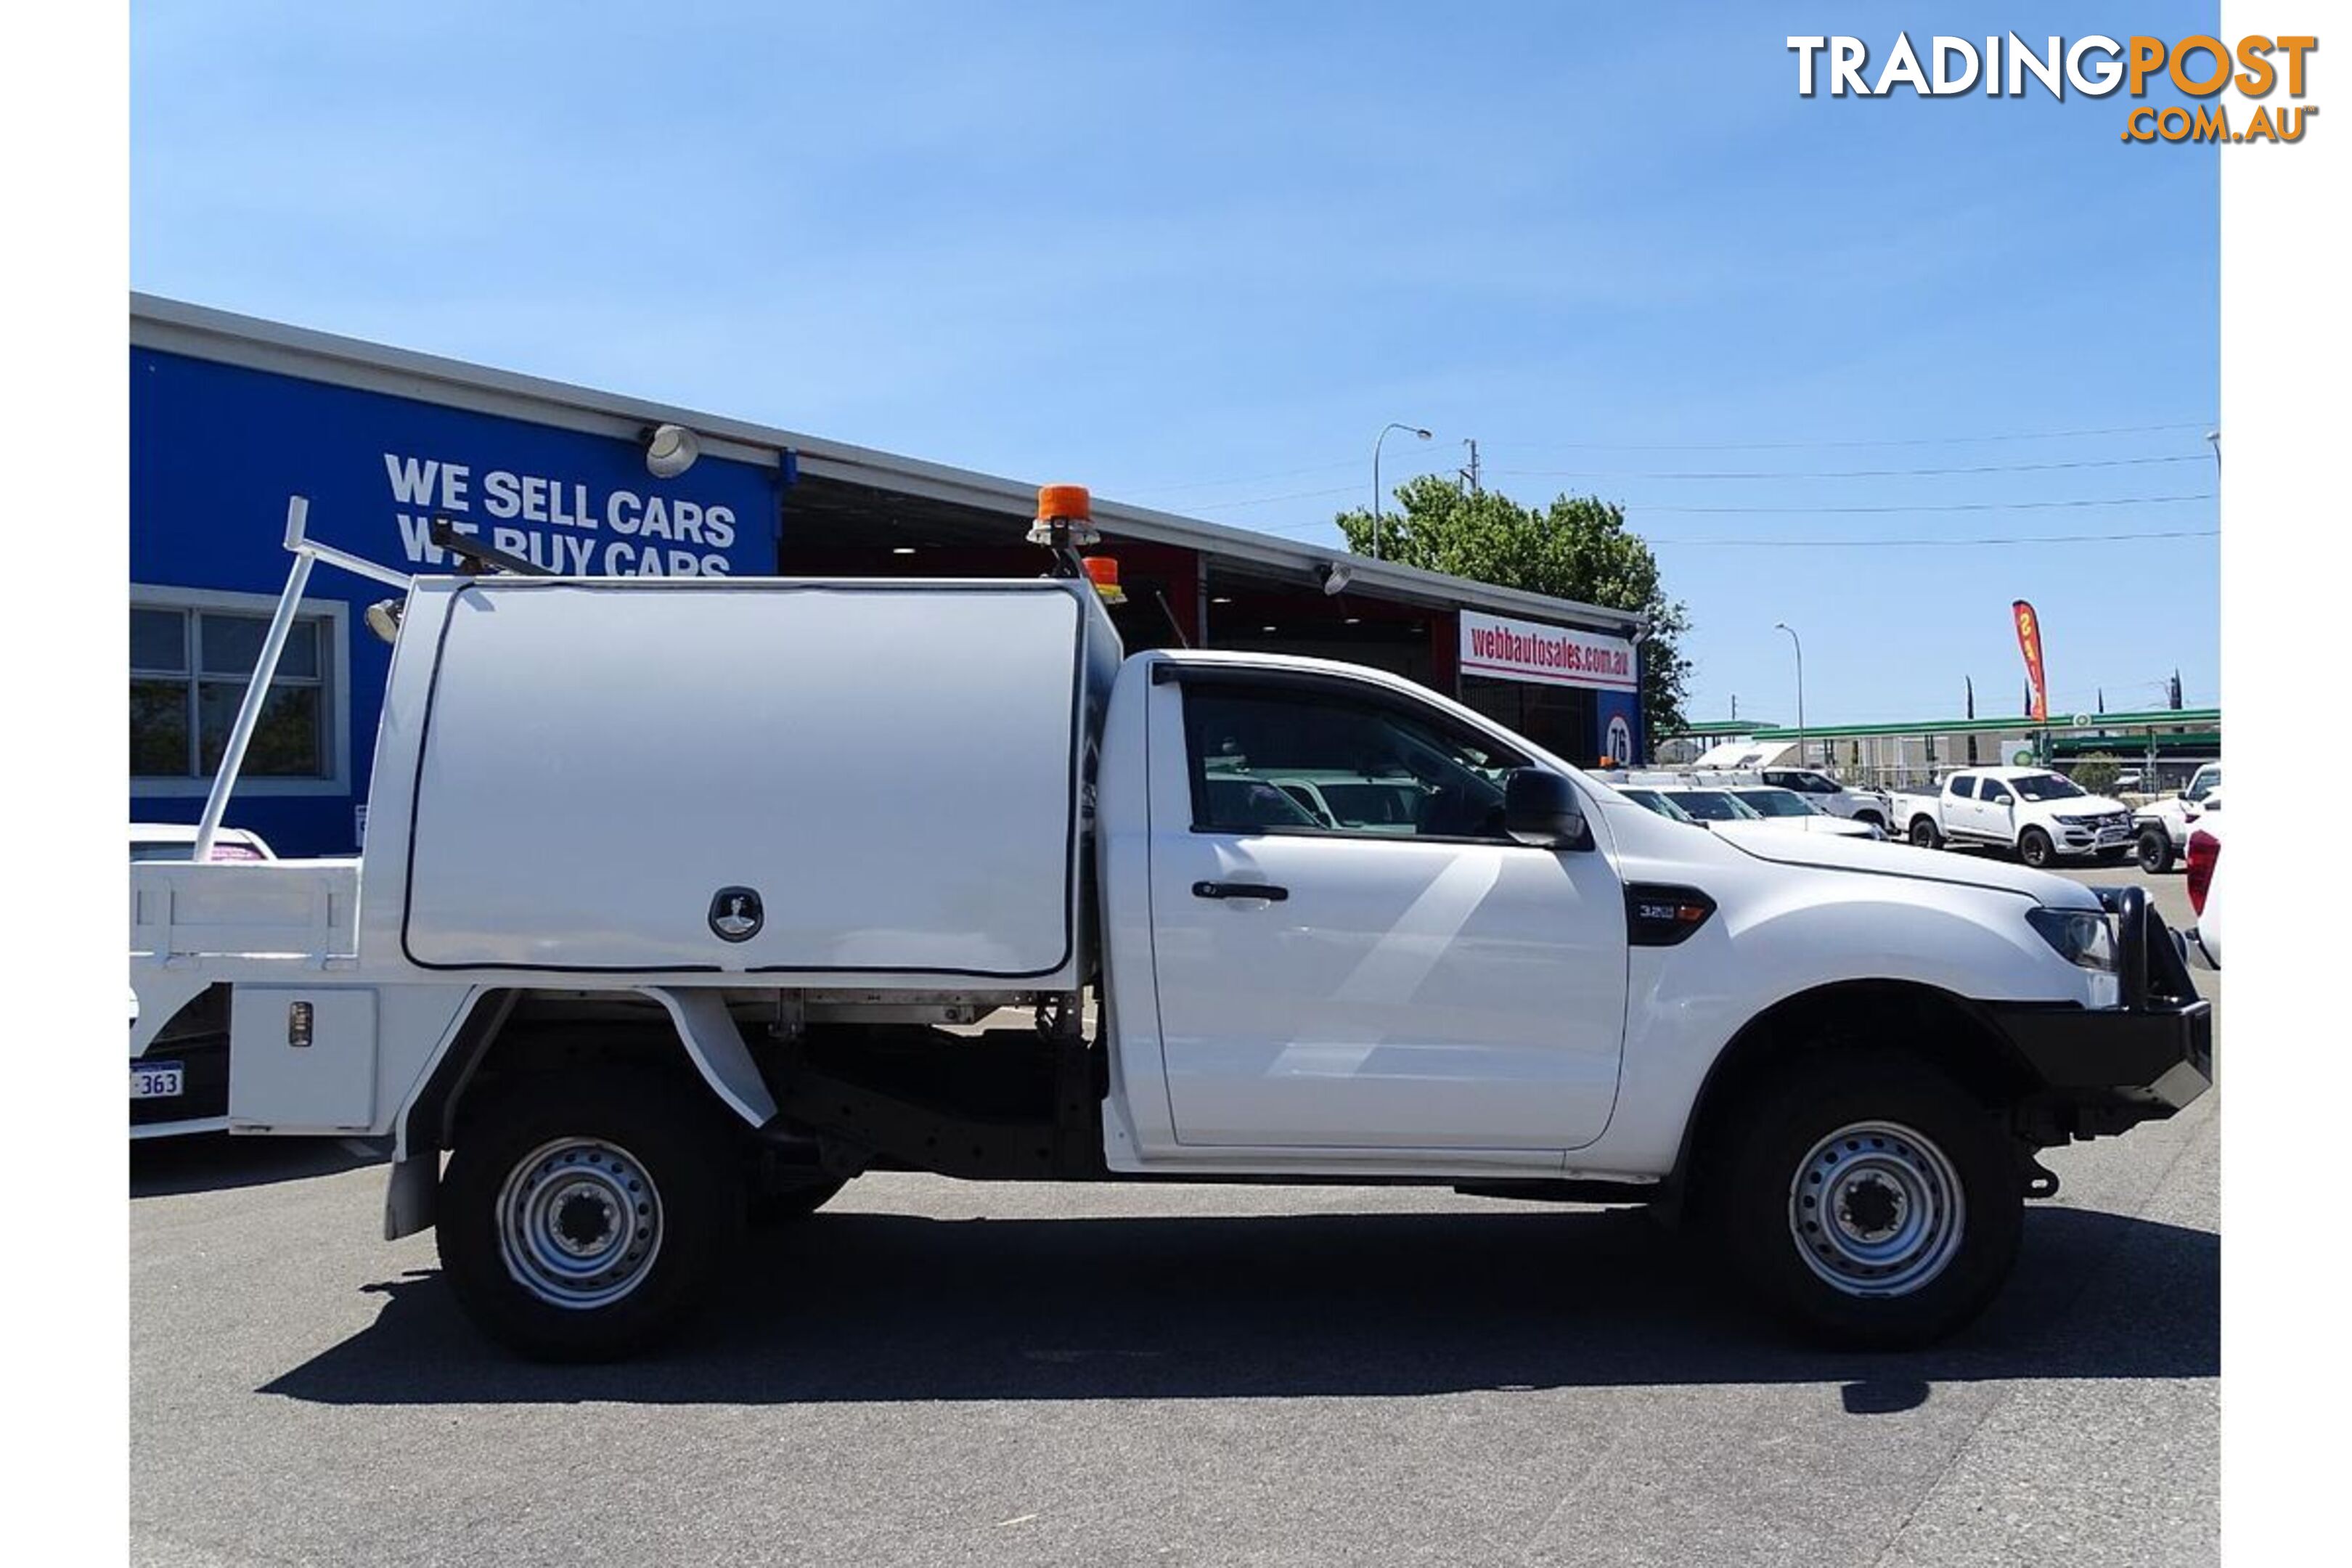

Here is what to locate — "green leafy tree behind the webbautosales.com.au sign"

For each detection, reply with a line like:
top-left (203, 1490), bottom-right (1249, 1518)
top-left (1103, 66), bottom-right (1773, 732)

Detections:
top-left (1339, 475), bottom-right (1691, 748)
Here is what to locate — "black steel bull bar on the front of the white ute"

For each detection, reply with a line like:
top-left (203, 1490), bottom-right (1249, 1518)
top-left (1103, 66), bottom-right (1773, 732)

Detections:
top-left (1990, 889), bottom-right (2213, 1145)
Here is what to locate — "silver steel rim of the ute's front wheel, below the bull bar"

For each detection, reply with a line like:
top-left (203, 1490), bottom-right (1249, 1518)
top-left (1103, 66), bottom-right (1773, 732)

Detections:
top-left (1787, 1122), bottom-right (1969, 1295)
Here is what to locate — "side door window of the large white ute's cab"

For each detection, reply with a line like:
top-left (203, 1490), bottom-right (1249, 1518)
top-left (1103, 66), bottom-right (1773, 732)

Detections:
top-left (1183, 682), bottom-right (1524, 839)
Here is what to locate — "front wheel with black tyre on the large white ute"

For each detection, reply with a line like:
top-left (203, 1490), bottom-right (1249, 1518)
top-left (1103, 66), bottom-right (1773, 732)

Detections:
top-left (1710, 1051), bottom-right (2025, 1349)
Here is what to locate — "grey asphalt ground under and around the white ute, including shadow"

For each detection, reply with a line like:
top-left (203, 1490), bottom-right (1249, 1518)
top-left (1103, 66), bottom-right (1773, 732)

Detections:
top-left (129, 870), bottom-right (2221, 1568)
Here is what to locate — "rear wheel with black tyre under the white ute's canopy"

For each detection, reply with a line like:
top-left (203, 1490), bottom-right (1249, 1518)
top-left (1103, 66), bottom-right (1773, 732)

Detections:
top-left (435, 1072), bottom-right (743, 1361)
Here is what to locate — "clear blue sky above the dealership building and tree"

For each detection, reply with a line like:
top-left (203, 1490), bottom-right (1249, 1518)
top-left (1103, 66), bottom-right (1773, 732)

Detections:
top-left (131, 2), bottom-right (2210, 724)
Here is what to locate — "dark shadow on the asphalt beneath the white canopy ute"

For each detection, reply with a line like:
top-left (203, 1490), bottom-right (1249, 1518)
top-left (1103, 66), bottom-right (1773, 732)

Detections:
top-left (261, 1209), bottom-right (2221, 1416)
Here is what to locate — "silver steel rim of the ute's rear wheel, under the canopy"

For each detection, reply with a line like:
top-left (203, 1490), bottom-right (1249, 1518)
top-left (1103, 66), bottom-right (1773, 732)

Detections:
top-left (497, 1138), bottom-right (663, 1312)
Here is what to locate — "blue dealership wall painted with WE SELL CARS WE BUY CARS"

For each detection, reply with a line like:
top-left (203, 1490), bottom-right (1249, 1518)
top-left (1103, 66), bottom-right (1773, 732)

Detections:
top-left (129, 348), bottom-right (793, 856)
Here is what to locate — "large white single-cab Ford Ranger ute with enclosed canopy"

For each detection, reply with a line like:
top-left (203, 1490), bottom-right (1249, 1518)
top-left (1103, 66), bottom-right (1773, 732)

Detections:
top-left (129, 499), bottom-right (2211, 1359)
